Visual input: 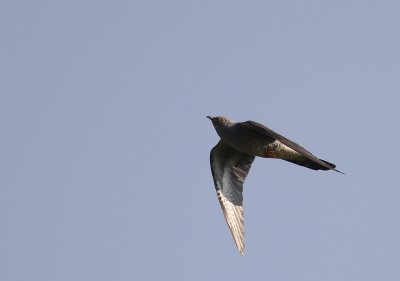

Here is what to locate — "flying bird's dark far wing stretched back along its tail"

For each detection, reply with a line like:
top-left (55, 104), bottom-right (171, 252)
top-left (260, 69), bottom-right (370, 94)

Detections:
top-left (241, 121), bottom-right (341, 170)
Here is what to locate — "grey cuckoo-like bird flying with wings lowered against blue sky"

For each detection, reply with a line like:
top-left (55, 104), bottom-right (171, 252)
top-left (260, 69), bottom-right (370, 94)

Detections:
top-left (207, 116), bottom-right (344, 255)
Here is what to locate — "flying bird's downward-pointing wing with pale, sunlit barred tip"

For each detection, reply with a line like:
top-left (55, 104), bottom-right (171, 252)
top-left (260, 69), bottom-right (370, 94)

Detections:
top-left (210, 141), bottom-right (254, 255)
